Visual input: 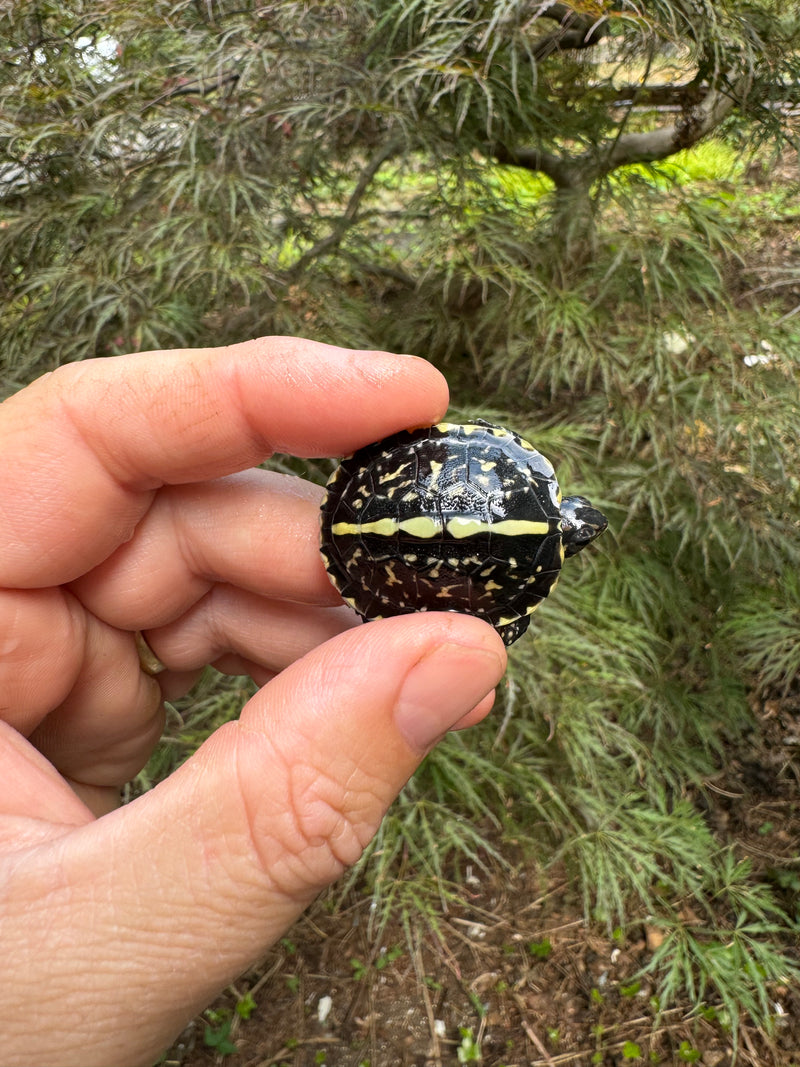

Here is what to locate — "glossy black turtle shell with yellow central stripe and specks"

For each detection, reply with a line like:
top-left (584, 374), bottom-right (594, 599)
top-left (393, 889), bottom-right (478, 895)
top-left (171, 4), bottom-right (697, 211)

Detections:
top-left (321, 421), bottom-right (564, 644)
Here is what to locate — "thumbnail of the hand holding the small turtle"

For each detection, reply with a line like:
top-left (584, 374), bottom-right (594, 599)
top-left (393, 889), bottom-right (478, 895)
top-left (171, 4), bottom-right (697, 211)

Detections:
top-left (395, 643), bottom-right (506, 752)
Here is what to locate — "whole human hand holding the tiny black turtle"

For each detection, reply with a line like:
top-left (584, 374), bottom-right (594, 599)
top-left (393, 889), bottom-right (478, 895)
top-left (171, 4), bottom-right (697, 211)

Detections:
top-left (0, 337), bottom-right (506, 1067)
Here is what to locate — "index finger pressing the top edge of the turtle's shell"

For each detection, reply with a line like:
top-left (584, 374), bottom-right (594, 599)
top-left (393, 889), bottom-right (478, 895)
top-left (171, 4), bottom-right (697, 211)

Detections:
top-left (0, 337), bottom-right (447, 587)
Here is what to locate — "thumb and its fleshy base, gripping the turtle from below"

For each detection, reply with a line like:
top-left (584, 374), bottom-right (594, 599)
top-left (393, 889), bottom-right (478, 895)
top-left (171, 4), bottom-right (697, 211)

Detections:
top-left (4, 614), bottom-right (506, 1065)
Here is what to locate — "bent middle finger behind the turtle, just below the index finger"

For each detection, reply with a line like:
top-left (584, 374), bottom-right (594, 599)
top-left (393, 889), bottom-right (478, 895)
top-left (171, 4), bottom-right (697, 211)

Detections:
top-left (70, 469), bottom-right (341, 630)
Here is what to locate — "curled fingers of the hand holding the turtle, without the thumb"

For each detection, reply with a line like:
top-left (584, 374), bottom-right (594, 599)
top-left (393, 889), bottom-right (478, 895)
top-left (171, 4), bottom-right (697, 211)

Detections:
top-left (0, 337), bottom-right (447, 810)
